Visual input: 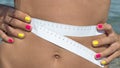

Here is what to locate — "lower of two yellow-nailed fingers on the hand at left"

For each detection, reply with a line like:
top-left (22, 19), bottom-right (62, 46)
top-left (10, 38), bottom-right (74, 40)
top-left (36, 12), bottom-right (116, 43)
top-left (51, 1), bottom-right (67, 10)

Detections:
top-left (6, 25), bottom-right (25, 38)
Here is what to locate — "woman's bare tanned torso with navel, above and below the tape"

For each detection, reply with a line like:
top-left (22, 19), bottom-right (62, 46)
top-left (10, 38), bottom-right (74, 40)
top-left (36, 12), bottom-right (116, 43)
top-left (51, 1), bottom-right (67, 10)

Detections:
top-left (1, 0), bottom-right (110, 68)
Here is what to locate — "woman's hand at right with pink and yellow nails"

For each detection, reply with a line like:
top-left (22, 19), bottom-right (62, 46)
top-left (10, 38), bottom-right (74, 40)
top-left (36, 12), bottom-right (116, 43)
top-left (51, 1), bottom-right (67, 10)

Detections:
top-left (92, 23), bottom-right (120, 65)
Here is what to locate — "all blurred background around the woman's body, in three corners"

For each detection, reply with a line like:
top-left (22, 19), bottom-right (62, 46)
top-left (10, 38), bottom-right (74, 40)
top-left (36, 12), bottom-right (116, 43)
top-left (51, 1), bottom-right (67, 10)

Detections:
top-left (0, 0), bottom-right (120, 68)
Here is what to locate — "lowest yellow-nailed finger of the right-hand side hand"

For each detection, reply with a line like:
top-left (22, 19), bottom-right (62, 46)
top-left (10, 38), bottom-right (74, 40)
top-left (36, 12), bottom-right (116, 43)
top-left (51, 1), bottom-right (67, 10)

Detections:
top-left (101, 50), bottom-right (120, 65)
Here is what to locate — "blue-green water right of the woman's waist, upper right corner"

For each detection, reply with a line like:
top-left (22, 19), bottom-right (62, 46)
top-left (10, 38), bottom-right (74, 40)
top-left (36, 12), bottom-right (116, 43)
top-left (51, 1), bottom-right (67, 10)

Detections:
top-left (108, 0), bottom-right (120, 34)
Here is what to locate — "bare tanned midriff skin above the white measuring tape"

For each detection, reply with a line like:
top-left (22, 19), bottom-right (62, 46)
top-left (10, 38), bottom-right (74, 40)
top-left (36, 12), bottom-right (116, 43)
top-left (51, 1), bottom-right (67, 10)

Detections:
top-left (16, 0), bottom-right (109, 26)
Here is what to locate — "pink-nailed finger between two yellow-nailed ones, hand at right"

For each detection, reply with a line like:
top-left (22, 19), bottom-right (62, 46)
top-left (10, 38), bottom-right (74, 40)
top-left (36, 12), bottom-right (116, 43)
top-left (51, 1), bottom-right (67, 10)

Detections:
top-left (95, 42), bottom-right (120, 59)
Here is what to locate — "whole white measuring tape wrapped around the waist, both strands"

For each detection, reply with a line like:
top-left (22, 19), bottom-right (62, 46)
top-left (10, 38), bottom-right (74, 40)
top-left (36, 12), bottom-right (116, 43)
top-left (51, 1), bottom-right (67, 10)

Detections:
top-left (31, 18), bottom-right (104, 67)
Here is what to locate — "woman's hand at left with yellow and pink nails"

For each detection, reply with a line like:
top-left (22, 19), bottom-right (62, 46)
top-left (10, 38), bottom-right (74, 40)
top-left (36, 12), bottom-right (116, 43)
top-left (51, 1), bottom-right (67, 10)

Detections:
top-left (0, 5), bottom-right (31, 43)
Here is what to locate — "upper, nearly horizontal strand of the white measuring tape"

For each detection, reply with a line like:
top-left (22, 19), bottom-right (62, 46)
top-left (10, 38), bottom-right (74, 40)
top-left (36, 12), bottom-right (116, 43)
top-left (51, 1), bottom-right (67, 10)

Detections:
top-left (31, 18), bottom-right (104, 37)
